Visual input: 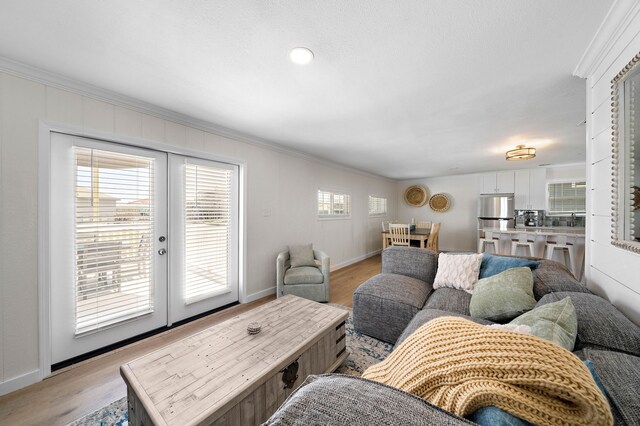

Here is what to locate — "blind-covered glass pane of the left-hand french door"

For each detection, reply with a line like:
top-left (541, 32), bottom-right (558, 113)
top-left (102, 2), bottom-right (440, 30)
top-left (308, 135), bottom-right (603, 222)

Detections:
top-left (74, 147), bottom-right (154, 335)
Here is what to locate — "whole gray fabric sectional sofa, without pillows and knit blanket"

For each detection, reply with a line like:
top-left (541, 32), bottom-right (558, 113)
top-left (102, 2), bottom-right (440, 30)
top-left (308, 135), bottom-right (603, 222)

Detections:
top-left (269, 247), bottom-right (640, 425)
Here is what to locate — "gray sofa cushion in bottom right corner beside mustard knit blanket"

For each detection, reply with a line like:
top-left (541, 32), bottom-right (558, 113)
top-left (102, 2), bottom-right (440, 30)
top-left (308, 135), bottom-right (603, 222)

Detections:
top-left (583, 348), bottom-right (640, 425)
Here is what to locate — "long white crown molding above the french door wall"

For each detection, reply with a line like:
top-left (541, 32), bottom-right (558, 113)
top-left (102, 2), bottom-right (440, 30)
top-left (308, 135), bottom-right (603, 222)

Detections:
top-left (0, 56), bottom-right (397, 182)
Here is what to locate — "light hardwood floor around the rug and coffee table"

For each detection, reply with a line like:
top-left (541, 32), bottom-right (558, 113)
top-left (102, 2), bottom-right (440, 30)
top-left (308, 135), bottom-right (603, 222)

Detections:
top-left (0, 255), bottom-right (381, 425)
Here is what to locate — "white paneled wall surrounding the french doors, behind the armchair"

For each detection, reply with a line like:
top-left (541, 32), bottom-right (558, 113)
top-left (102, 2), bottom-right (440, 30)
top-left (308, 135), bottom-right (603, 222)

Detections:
top-left (0, 73), bottom-right (396, 394)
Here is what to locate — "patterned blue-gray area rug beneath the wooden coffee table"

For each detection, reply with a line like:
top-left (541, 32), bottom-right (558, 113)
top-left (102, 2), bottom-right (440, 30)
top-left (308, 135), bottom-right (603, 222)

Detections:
top-left (69, 303), bottom-right (393, 426)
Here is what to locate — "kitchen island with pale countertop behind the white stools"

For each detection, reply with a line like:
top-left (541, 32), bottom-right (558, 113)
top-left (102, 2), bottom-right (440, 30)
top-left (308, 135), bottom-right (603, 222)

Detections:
top-left (478, 226), bottom-right (585, 280)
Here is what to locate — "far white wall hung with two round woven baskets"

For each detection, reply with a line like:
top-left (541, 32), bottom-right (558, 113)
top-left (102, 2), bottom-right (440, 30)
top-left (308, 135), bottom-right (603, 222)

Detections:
top-left (398, 164), bottom-right (586, 251)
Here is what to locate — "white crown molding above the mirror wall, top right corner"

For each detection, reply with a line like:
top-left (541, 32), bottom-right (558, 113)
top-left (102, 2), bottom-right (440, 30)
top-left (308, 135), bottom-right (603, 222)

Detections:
top-left (573, 0), bottom-right (640, 78)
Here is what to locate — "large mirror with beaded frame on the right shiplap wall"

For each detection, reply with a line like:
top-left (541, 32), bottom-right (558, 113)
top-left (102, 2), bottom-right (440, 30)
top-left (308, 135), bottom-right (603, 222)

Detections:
top-left (611, 53), bottom-right (640, 253)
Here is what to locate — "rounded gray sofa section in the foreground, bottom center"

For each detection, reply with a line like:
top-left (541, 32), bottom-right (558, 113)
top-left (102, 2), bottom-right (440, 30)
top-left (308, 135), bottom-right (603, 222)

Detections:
top-left (265, 374), bottom-right (473, 426)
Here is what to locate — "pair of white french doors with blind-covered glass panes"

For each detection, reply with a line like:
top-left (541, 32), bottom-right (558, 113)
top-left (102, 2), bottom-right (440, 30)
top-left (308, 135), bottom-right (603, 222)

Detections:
top-left (49, 133), bottom-right (238, 363)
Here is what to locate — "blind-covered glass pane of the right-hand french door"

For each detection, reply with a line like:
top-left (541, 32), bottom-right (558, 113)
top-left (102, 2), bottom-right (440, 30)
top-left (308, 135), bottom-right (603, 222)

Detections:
top-left (184, 164), bottom-right (232, 304)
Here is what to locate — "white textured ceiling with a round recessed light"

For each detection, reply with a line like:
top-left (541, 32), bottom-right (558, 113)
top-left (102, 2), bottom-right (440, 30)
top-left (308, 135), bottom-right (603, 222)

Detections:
top-left (0, 0), bottom-right (612, 179)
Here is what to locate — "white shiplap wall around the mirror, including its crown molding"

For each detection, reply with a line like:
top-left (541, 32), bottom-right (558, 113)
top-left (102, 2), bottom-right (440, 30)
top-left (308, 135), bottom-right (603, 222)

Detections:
top-left (576, 0), bottom-right (640, 324)
